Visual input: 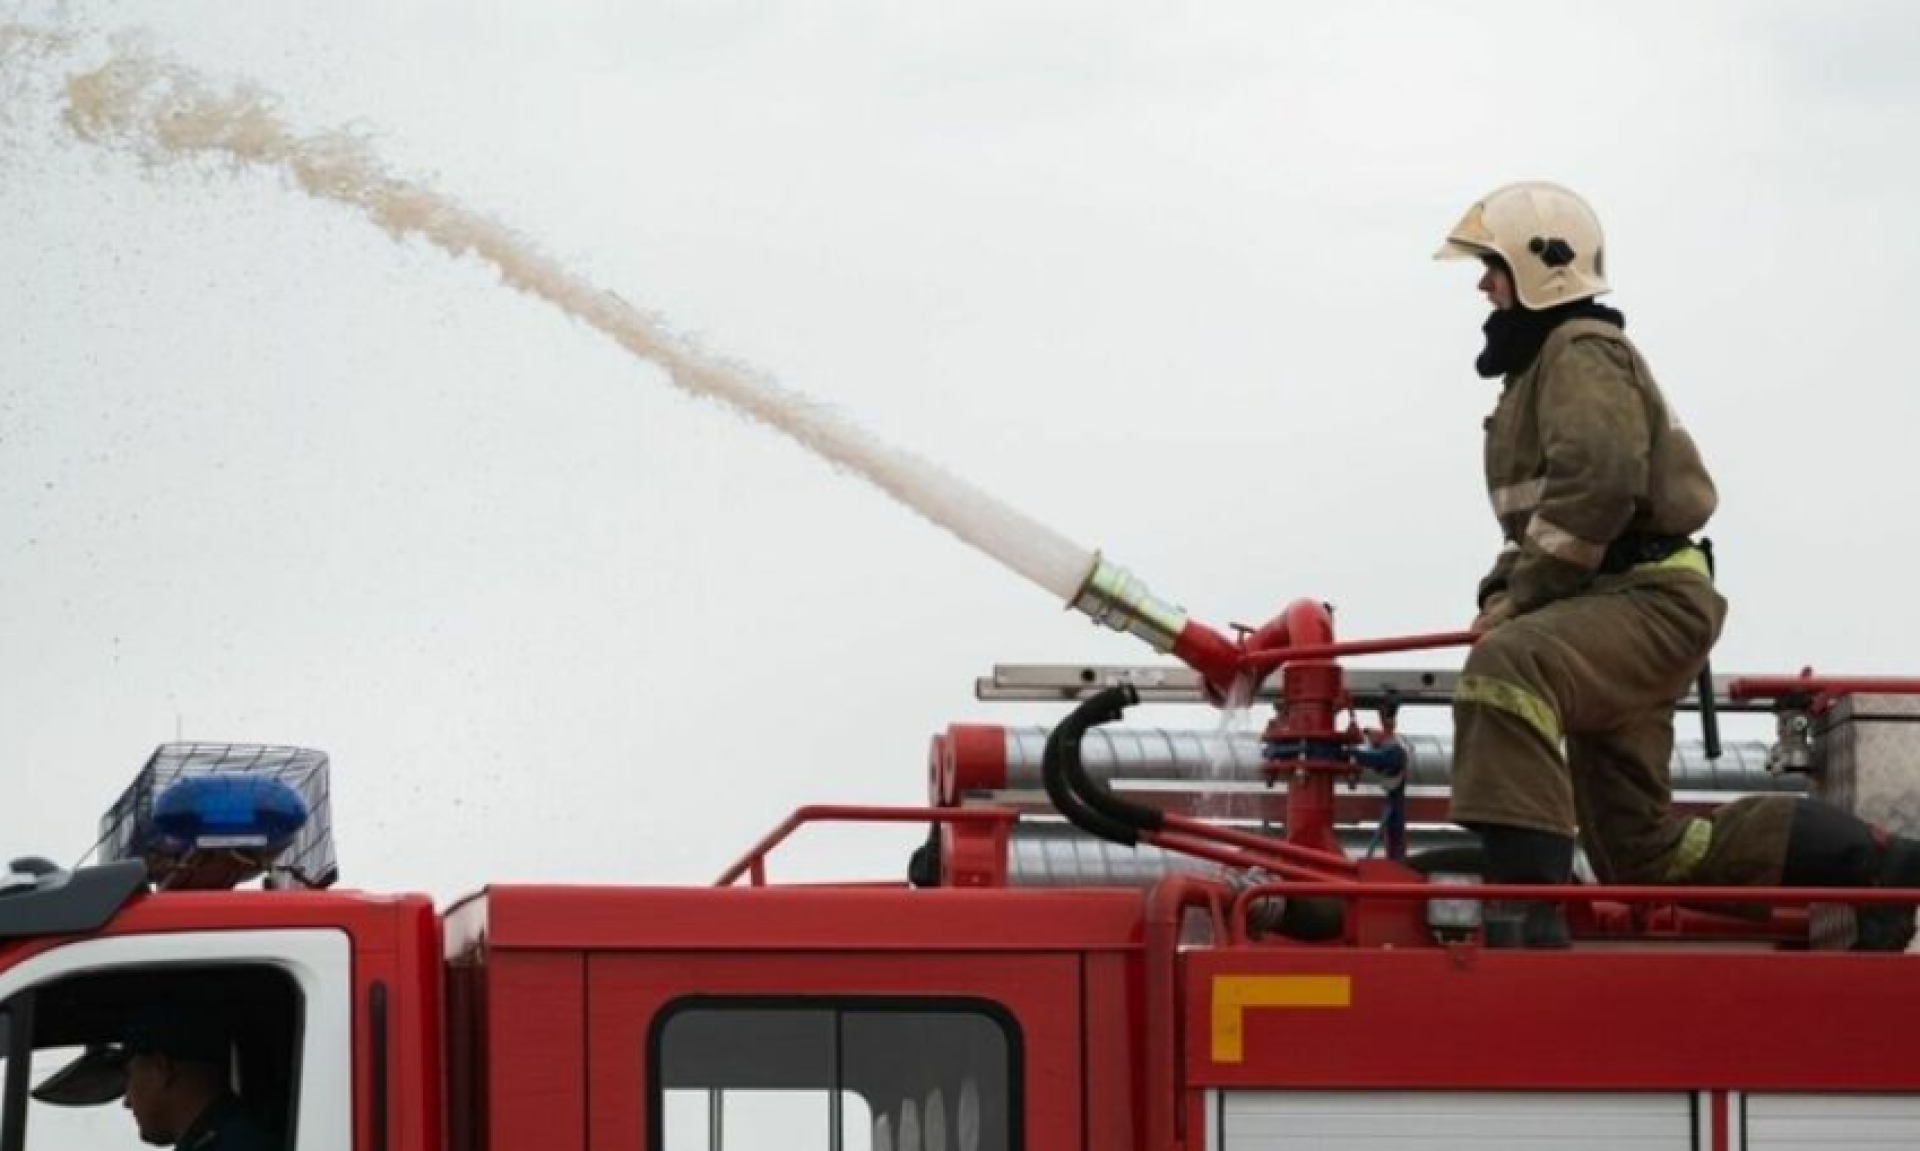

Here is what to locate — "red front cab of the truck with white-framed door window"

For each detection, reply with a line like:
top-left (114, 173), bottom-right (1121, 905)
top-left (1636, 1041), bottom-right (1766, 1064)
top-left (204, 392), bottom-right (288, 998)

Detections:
top-left (0, 865), bottom-right (442, 1151)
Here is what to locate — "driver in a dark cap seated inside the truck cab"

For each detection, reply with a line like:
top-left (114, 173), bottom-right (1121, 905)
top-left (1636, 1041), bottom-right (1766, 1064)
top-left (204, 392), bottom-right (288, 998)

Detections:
top-left (123, 1005), bottom-right (280, 1151)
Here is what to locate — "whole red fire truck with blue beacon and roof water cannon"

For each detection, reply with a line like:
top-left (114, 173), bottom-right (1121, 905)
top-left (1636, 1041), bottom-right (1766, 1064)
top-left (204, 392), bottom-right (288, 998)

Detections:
top-left (0, 563), bottom-right (1920, 1151)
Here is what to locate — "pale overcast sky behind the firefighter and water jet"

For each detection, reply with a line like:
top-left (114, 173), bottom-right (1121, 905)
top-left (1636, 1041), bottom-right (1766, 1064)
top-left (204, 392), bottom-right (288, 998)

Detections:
top-left (0, 0), bottom-right (1920, 897)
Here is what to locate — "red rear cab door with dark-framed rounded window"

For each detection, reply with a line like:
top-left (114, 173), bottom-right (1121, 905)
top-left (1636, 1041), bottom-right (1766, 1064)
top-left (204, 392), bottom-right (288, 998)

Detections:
top-left (588, 951), bottom-right (1083, 1151)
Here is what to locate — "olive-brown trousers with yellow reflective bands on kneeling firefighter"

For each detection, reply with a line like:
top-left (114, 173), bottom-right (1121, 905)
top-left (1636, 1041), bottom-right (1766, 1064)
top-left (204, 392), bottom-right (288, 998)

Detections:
top-left (1453, 563), bottom-right (1793, 884)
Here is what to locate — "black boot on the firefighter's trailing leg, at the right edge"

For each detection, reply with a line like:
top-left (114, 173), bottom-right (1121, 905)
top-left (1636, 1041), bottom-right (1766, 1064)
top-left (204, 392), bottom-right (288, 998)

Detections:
top-left (1780, 799), bottom-right (1920, 951)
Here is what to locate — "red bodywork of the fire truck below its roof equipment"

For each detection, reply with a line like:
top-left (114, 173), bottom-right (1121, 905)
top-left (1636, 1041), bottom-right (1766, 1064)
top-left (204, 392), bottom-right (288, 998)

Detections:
top-left (11, 880), bottom-right (1920, 1151)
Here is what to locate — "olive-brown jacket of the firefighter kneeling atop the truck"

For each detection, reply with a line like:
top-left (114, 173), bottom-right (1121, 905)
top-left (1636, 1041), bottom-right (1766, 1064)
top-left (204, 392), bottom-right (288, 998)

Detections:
top-left (1480, 319), bottom-right (1716, 613)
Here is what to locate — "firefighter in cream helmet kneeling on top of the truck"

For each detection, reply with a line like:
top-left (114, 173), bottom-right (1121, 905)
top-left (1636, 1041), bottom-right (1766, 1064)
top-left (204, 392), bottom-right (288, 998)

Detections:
top-left (1436, 183), bottom-right (1920, 951)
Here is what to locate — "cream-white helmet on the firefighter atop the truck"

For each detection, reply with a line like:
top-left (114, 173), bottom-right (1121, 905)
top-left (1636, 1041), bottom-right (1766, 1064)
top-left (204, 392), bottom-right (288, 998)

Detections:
top-left (1434, 181), bottom-right (1611, 311)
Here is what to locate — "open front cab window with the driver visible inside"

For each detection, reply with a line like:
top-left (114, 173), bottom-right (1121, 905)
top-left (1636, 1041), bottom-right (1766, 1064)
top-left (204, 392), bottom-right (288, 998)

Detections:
top-left (0, 965), bottom-right (301, 1151)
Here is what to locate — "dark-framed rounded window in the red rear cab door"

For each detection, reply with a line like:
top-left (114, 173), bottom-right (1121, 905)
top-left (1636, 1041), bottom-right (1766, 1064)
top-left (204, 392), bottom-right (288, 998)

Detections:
top-left (649, 999), bottom-right (1020, 1151)
